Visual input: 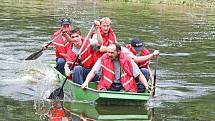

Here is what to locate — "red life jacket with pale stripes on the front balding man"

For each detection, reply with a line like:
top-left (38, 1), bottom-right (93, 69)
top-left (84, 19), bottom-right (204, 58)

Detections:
top-left (98, 52), bottom-right (137, 92)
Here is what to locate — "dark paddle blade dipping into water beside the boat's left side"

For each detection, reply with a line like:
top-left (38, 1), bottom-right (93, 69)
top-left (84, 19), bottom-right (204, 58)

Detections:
top-left (48, 88), bottom-right (64, 100)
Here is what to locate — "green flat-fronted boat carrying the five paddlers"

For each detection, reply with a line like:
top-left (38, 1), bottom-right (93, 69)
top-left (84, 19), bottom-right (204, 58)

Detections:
top-left (48, 61), bottom-right (152, 105)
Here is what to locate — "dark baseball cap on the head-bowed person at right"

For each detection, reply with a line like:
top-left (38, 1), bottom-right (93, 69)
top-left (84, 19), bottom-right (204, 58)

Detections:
top-left (130, 38), bottom-right (144, 51)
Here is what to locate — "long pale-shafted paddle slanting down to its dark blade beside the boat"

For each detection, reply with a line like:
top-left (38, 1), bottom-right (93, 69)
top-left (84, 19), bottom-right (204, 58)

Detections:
top-left (48, 24), bottom-right (94, 100)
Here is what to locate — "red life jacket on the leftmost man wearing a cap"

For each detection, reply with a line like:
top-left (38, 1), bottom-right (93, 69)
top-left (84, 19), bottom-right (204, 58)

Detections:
top-left (52, 30), bottom-right (71, 58)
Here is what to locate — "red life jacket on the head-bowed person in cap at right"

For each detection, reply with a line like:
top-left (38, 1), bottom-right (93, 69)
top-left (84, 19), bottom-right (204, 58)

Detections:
top-left (125, 44), bottom-right (150, 68)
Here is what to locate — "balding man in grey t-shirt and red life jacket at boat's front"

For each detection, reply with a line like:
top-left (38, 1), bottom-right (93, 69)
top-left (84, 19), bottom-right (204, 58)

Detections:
top-left (82, 43), bottom-right (152, 92)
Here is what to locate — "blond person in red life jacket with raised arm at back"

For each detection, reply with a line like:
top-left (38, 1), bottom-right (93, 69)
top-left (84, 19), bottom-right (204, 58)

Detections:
top-left (92, 17), bottom-right (116, 58)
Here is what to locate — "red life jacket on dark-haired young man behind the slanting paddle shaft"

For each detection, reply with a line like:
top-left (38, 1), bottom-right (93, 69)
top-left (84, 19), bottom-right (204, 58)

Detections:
top-left (64, 38), bottom-right (96, 69)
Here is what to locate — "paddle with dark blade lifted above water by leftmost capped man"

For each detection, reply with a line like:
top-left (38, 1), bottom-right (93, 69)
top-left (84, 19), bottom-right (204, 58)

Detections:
top-left (25, 34), bottom-right (62, 60)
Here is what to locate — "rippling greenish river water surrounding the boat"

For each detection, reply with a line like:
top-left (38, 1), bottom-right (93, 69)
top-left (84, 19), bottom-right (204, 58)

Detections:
top-left (0, 0), bottom-right (215, 121)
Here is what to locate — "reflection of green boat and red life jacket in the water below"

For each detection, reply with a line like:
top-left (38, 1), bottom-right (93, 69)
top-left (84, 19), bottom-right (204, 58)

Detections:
top-left (36, 101), bottom-right (153, 121)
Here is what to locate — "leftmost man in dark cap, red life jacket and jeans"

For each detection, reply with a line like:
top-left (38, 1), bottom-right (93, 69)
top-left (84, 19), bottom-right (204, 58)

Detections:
top-left (43, 18), bottom-right (73, 74)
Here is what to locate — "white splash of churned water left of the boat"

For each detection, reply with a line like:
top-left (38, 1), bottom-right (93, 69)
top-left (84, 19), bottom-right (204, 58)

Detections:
top-left (0, 61), bottom-right (56, 101)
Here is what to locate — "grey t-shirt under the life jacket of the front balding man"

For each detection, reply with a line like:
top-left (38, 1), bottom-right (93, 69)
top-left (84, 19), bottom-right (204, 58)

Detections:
top-left (92, 58), bottom-right (141, 80)
